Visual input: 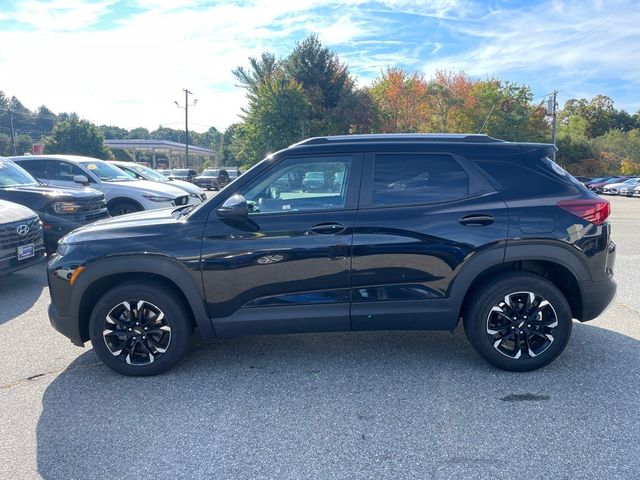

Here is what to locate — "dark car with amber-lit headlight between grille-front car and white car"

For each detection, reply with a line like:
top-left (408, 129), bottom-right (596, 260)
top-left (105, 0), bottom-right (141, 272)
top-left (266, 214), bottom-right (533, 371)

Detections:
top-left (0, 158), bottom-right (109, 252)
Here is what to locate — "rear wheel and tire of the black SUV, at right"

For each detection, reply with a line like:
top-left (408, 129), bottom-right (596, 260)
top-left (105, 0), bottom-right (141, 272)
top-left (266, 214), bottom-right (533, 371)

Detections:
top-left (463, 272), bottom-right (573, 372)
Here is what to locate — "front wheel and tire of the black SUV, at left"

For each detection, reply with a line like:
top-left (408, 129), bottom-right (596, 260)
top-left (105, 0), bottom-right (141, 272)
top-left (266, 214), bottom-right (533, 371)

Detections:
top-left (89, 281), bottom-right (193, 376)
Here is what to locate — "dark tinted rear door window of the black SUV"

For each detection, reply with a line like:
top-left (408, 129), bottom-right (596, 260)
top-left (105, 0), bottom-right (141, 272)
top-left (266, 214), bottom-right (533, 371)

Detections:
top-left (373, 154), bottom-right (469, 205)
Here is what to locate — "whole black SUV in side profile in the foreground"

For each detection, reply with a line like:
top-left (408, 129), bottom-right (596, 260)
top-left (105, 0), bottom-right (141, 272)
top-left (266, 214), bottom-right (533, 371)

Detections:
top-left (48, 135), bottom-right (616, 375)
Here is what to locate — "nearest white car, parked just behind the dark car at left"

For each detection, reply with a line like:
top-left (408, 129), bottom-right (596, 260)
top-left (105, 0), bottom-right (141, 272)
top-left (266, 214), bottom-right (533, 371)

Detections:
top-left (11, 155), bottom-right (189, 216)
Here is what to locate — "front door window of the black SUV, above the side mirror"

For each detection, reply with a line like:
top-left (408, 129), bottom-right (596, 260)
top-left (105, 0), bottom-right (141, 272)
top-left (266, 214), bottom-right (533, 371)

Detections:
top-left (243, 156), bottom-right (351, 213)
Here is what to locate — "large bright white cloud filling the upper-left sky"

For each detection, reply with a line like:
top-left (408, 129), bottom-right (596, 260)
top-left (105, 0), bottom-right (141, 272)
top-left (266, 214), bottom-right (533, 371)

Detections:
top-left (0, 0), bottom-right (370, 130)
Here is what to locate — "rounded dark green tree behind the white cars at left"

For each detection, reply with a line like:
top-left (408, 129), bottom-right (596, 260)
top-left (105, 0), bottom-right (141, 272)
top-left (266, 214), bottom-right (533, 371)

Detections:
top-left (44, 114), bottom-right (111, 159)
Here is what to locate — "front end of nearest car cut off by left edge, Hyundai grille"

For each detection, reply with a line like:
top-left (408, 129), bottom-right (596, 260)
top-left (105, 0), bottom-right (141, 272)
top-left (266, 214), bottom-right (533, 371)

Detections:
top-left (0, 198), bottom-right (45, 275)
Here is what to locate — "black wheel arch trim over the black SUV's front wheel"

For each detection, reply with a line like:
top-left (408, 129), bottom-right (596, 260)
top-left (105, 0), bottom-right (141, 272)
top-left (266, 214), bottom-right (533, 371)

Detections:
top-left (69, 254), bottom-right (215, 341)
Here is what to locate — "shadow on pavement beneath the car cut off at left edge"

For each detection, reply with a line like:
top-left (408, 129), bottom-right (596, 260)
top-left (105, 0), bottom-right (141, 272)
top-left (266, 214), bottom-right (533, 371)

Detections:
top-left (0, 264), bottom-right (47, 325)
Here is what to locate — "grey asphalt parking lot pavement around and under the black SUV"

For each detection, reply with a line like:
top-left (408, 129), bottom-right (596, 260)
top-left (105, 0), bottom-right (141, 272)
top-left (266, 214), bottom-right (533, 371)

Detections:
top-left (0, 198), bottom-right (640, 480)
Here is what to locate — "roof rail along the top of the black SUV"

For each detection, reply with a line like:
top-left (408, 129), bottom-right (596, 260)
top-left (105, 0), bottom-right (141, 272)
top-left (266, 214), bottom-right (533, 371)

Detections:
top-left (295, 133), bottom-right (504, 146)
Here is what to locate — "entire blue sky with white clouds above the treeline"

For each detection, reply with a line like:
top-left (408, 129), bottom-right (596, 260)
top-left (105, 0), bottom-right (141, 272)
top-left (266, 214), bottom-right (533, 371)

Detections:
top-left (0, 0), bottom-right (640, 131)
